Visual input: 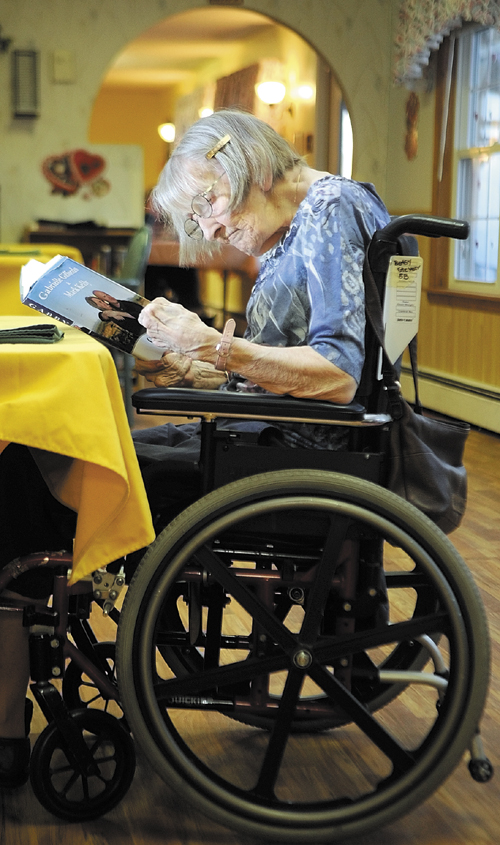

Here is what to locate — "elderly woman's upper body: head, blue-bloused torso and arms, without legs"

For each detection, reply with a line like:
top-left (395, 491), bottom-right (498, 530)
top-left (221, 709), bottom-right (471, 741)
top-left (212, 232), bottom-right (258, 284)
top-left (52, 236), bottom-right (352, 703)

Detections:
top-left (134, 111), bottom-right (389, 464)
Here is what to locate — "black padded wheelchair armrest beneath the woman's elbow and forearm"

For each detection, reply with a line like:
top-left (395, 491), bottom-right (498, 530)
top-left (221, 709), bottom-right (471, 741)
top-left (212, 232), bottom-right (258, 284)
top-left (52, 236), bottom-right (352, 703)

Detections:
top-left (132, 387), bottom-right (390, 425)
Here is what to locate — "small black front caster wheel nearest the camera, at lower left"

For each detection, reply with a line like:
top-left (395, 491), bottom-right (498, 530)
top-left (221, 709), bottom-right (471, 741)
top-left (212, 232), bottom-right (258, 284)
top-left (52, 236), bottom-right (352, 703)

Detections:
top-left (30, 708), bottom-right (135, 822)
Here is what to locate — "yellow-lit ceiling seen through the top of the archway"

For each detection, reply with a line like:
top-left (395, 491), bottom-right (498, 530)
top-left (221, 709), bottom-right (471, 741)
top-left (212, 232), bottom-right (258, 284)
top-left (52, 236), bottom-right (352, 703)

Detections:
top-left (104, 6), bottom-right (277, 86)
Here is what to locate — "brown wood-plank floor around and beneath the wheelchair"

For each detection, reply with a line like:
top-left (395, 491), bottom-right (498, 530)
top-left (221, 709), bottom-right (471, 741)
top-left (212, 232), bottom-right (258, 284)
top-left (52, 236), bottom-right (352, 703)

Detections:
top-left (0, 431), bottom-right (500, 845)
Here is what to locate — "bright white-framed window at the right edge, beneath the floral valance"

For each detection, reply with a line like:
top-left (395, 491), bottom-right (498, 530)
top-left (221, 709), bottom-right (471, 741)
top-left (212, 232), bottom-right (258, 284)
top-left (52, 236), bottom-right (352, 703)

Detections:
top-left (448, 29), bottom-right (500, 296)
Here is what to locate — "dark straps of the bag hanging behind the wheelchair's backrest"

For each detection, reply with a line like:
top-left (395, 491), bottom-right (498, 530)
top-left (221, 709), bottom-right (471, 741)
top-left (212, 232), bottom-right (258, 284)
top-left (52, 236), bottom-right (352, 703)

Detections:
top-left (363, 254), bottom-right (422, 420)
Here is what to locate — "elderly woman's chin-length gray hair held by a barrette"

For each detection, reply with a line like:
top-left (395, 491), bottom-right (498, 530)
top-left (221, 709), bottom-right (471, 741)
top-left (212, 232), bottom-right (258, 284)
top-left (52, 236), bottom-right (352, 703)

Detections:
top-left (151, 109), bottom-right (303, 263)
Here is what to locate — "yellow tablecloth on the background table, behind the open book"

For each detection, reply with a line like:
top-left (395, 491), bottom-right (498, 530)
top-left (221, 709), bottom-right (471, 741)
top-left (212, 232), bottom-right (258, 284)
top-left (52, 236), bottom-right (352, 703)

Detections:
top-left (0, 243), bottom-right (83, 317)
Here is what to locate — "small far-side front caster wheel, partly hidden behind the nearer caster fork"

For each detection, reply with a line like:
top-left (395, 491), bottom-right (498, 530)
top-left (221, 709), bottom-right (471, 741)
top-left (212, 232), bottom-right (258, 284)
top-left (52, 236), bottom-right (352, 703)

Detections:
top-left (62, 641), bottom-right (126, 727)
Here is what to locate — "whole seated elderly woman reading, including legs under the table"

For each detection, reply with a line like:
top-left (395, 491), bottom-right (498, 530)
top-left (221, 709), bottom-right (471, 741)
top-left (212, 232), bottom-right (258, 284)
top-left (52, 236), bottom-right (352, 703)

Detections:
top-left (0, 111), bottom-right (389, 787)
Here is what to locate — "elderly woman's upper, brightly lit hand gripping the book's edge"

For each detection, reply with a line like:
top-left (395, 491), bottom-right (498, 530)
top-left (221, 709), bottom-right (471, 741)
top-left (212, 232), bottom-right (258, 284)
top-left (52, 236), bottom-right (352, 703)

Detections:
top-left (139, 297), bottom-right (221, 363)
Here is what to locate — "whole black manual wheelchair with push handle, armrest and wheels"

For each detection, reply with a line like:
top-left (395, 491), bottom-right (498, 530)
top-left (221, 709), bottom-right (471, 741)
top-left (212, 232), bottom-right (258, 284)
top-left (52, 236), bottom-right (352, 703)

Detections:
top-left (0, 215), bottom-right (492, 844)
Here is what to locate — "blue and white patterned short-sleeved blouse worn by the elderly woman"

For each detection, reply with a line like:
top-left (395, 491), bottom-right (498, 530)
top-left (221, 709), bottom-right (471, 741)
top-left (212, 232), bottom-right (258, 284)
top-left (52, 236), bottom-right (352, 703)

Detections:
top-left (230, 176), bottom-right (390, 449)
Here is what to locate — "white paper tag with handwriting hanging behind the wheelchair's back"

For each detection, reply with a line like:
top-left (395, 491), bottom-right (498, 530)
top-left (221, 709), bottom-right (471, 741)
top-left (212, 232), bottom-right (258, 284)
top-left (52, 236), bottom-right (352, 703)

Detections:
top-left (383, 255), bottom-right (423, 364)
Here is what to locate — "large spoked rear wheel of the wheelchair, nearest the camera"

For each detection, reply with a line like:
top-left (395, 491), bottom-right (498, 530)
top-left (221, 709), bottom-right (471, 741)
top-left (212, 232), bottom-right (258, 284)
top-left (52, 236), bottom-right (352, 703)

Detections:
top-left (117, 470), bottom-right (489, 843)
